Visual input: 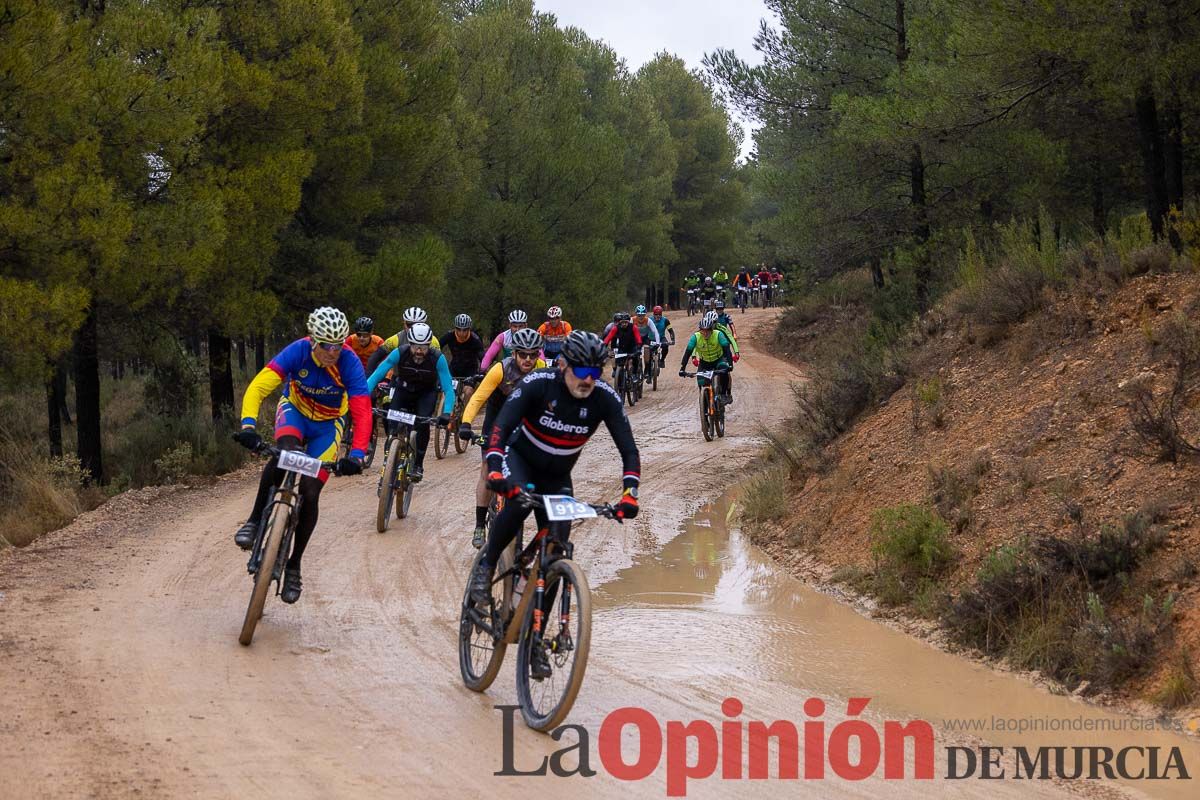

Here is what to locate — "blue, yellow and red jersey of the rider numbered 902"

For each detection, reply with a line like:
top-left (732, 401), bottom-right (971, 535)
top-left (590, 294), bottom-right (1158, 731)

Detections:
top-left (234, 337), bottom-right (370, 425)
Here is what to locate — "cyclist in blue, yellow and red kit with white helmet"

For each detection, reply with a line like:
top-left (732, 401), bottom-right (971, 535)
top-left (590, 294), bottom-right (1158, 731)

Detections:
top-left (234, 306), bottom-right (371, 603)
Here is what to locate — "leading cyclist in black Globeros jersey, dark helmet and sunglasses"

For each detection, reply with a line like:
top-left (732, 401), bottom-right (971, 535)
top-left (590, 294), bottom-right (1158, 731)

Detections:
top-left (470, 331), bottom-right (641, 680)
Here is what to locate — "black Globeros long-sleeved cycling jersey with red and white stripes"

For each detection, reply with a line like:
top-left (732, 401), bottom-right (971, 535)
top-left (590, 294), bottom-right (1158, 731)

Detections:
top-left (487, 369), bottom-right (642, 488)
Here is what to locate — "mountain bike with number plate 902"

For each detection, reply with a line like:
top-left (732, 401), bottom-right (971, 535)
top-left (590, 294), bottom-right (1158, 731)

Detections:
top-left (238, 444), bottom-right (338, 646)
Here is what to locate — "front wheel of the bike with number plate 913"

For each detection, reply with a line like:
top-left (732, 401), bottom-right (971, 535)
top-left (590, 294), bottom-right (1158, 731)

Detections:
top-left (517, 559), bottom-right (592, 732)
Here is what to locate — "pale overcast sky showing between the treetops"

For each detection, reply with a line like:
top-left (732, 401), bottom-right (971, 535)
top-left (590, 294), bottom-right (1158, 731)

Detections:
top-left (534, 0), bottom-right (767, 158)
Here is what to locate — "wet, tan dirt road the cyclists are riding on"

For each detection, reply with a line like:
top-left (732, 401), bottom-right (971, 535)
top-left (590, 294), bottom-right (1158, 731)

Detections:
top-left (0, 312), bottom-right (1180, 798)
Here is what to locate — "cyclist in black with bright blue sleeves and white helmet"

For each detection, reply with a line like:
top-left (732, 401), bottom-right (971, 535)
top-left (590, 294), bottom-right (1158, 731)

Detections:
top-left (367, 323), bottom-right (454, 483)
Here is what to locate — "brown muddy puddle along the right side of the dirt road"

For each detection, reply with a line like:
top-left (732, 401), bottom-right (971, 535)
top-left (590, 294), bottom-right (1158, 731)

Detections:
top-left (593, 497), bottom-right (1200, 799)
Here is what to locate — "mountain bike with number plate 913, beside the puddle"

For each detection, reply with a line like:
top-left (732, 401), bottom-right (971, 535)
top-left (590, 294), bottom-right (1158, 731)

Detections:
top-left (458, 489), bottom-right (620, 732)
